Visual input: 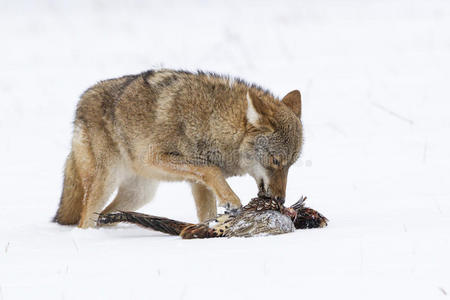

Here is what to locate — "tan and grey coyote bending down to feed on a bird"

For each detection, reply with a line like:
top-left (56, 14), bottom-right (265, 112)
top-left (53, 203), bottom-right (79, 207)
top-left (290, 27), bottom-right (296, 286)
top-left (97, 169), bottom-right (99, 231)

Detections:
top-left (54, 69), bottom-right (302, 228)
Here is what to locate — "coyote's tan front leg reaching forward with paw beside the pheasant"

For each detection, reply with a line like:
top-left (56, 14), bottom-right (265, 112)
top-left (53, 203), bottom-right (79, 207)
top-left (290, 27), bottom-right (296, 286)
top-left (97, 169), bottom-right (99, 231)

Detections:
top-left (149, 154), bottom-right (241, 208)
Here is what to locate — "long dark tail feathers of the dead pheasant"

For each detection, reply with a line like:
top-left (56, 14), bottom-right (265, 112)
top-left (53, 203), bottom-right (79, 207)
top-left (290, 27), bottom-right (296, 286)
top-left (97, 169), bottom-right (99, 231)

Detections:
top-left (97, 211), bottom-right (193, 235)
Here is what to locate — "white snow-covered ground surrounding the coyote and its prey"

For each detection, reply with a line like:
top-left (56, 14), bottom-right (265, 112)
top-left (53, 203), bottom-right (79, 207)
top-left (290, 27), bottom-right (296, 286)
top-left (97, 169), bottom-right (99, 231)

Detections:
top-left (0, 0), bottom-right (450, 300)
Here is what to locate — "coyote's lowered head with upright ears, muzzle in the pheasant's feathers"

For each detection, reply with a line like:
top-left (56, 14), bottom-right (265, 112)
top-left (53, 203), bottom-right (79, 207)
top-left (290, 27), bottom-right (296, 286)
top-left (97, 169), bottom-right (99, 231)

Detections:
top-left (246, 90), bottom-right (303, 203)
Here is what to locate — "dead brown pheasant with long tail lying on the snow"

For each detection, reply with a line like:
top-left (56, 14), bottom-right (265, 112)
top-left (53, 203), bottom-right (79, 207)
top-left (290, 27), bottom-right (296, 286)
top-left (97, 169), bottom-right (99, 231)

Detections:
top-left (97, 197), bottom-right (328, 239)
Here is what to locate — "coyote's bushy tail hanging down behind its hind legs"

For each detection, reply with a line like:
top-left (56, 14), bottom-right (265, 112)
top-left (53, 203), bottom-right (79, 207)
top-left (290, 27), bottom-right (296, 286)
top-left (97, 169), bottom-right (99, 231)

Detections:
top-left (53, 152), bottom-right (84, 225)
